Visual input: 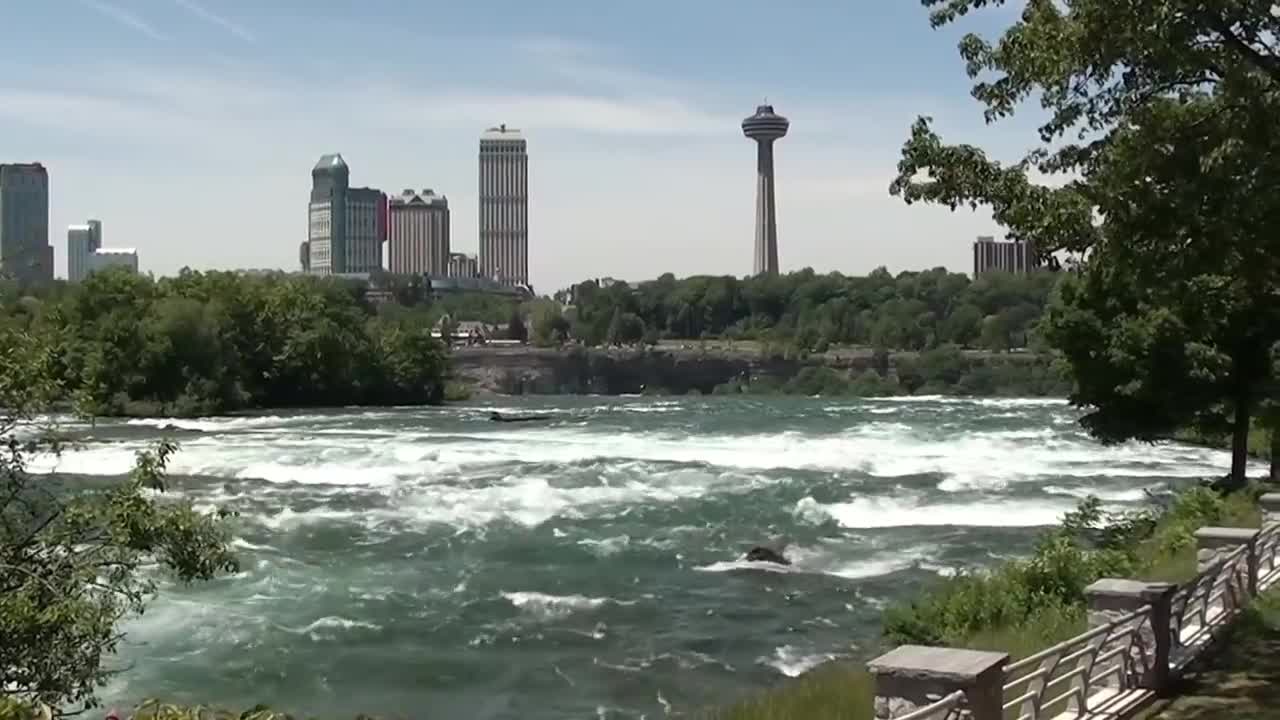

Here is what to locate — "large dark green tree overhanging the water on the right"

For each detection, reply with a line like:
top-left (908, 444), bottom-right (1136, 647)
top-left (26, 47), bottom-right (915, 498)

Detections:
top-left (891, 0), bottom-right (1280, 484)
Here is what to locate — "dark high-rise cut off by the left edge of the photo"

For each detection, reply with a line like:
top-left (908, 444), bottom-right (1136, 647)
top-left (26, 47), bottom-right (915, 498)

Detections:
top-left (0, 163), bottom-right (54, 283)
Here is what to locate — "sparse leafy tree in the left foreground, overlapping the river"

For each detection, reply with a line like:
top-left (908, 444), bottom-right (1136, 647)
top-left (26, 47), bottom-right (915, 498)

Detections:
top-left (0, 329), bottom-right (237, 708)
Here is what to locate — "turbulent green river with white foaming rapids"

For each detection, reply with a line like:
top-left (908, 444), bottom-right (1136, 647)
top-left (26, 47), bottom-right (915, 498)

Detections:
top-left (38, 397), bottom-right (1249, 720)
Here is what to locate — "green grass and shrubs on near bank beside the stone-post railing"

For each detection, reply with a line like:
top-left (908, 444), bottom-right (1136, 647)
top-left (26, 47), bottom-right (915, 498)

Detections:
top-left (701, 487), bottom-right (1264, 720)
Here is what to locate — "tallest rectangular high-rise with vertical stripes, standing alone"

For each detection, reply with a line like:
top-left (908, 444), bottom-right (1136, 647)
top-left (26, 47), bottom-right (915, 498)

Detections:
top-left (480, 126), bottom-right (529, 286)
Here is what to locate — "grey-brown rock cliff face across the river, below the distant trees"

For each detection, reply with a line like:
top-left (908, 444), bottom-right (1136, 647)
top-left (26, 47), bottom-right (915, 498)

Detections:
top-left (453, 347), bottom-right (891, 395)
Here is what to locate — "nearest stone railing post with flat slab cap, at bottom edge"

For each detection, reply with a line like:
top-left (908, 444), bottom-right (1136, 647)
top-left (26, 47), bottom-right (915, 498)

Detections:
top-left (867, 644), bottom-right (1009, 720)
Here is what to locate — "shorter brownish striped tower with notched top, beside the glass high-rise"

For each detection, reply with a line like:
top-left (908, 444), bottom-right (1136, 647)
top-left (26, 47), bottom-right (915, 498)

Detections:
top-left (387, 190), bottom-right (449, 277)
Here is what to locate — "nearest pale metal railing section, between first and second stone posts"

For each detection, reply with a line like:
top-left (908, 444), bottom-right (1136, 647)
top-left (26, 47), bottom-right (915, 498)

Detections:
top-left (1004, 607), bottom-right (1155, 720)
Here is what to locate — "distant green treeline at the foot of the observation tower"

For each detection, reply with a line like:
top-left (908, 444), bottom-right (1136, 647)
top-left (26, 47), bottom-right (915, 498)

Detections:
top-left (531, 268), bottom-right (1059, 352)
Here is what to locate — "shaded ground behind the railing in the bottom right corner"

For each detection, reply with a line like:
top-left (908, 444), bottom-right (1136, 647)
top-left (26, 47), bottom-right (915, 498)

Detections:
top-left (1140, 589), bottom-right (1280, 720)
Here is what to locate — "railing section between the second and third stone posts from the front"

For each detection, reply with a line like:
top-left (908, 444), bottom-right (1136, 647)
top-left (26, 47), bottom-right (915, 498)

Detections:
top-left (1169, 546), bottom-right (1249, 669)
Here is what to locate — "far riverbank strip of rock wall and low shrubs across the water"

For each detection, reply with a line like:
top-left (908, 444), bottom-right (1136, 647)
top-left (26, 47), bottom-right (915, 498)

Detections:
top-left (452, 341), bottom-right (1070, 397)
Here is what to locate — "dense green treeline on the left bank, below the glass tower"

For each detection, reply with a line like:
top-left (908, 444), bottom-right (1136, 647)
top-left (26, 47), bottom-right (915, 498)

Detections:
top-left (0, 270), bottom-right (448, 415)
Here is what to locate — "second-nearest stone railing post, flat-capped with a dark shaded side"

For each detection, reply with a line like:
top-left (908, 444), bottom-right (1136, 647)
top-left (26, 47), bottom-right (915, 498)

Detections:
top-left (1084, 578), bottom-right (1178, 694)
